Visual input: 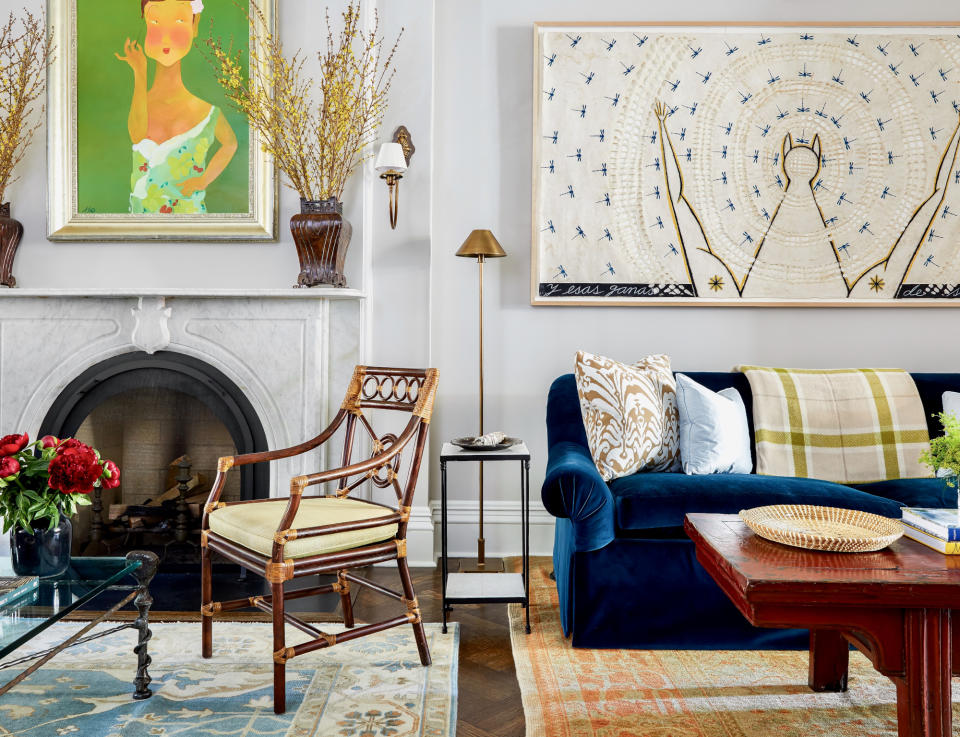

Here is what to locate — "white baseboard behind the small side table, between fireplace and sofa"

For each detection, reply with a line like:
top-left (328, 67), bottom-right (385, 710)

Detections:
top-left (430, 499), bottom-right (556, 558)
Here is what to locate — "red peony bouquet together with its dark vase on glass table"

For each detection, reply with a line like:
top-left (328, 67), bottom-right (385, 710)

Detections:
top-left (0, 433), bottom-right (120, 576)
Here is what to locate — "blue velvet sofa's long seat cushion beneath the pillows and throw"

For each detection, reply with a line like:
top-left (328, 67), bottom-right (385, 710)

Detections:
top-left (610, 473), bottom-right (908, 536)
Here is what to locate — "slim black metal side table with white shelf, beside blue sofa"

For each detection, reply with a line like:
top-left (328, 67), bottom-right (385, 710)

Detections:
top-left (440, 443), bottom-right (530, 635)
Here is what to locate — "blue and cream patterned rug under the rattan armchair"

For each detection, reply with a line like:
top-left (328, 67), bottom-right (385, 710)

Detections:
top-left (0, 622), bottom-right (459, 737)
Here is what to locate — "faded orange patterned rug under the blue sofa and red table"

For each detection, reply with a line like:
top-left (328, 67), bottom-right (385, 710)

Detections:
top-left (510, 559), bottom-right (960, 737)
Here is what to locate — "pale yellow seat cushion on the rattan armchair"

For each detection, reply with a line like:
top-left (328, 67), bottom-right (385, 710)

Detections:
top-left (210, 497), bottom-right (397, 558)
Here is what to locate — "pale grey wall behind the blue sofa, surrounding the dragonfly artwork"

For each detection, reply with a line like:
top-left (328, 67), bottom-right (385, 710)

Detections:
top-left (432, 0), bottom-right (960, 548)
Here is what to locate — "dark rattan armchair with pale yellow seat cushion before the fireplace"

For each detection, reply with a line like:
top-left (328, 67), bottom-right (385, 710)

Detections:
top-left (200, 366), bottom-right (437, 714)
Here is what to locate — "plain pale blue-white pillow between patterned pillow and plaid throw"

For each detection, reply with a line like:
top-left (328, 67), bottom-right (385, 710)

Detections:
top-left (677, 374), bottom-right (753, 475)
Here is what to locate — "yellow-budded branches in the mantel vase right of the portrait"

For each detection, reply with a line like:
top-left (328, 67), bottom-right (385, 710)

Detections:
top-left (206, 2), bottom-right (403, 200)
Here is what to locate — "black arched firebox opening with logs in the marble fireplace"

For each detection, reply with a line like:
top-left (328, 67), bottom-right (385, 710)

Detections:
top-left (40, 351), bottom-right (270, 562)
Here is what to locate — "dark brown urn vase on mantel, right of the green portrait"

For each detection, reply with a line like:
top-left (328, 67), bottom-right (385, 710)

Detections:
top-left (290, 197), bottom-right (353, 287)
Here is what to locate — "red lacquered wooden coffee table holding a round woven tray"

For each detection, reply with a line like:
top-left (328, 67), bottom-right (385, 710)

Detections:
top-left (684, 514), bottom-right (960, 737)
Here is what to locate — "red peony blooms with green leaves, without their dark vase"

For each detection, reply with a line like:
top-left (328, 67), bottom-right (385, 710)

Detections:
top-left (0, 433), bottom-right (120, 532)
